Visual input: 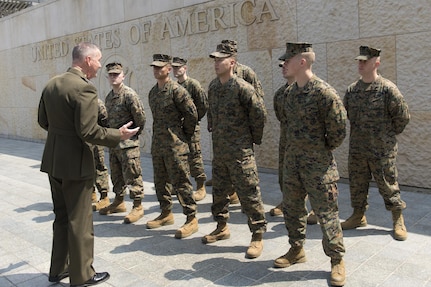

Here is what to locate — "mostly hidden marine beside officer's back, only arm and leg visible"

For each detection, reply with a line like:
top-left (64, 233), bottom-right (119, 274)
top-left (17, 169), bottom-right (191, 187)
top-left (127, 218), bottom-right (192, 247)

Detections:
top-left (93, 99), bottom-right (110, 210)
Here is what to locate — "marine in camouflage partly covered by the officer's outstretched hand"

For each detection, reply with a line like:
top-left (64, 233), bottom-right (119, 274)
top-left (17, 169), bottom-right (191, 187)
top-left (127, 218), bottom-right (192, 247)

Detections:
top-left (99, 63), bottom-right (146, 223)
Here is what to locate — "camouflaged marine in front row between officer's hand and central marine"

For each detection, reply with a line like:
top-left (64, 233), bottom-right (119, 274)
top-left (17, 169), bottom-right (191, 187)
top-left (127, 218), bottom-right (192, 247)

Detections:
top-left (147, 54), bottom-right (198, 239)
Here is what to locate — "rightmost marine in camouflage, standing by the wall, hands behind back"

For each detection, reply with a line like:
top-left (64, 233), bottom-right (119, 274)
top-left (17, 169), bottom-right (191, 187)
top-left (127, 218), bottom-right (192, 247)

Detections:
top-left (341, 46), bottom-right (410, 243)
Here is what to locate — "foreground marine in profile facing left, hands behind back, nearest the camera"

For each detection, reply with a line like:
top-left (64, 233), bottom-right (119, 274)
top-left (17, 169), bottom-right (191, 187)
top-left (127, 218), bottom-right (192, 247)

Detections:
top-left (274, 43), bottom-right (347, 286)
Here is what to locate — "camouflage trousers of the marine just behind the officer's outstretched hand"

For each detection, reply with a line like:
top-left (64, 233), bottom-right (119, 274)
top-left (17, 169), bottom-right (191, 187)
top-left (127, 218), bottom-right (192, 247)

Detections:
top-left (109, 147), bottom-right (144, 200)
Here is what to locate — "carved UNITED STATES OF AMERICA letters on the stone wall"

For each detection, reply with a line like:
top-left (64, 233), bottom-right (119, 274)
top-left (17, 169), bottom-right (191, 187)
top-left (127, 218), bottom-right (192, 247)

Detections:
top-left (31, 0), bottom-right (279, 62)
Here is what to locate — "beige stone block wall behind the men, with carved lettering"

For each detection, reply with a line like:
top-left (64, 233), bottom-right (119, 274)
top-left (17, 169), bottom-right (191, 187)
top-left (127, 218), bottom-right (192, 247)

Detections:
top-left (0, 0), bottom-right (431, 188)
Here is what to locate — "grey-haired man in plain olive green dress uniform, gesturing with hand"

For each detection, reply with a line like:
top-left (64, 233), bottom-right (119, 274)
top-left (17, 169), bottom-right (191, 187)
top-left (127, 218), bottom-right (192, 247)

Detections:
top-left (38, 43), bottom-right (139, 287)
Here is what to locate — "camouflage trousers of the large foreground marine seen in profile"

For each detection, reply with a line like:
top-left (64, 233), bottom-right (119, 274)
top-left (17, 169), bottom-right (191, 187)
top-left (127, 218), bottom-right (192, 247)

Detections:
top-left (283, 167), bottom-right (345, 258)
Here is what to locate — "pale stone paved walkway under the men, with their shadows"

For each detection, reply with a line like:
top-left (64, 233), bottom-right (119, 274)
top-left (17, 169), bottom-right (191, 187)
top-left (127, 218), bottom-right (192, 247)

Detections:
top-left (0, 138), bottom-right (431, 287)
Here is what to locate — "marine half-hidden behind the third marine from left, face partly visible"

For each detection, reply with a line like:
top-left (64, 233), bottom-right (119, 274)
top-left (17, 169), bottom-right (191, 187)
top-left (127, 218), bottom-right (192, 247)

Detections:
top-left (172, 57), bottom-right (208, 201)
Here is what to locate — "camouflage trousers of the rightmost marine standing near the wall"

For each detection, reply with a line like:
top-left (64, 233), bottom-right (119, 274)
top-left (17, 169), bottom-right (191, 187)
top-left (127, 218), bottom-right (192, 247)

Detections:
top-left (348, 153), bottom-right (406, 210)
